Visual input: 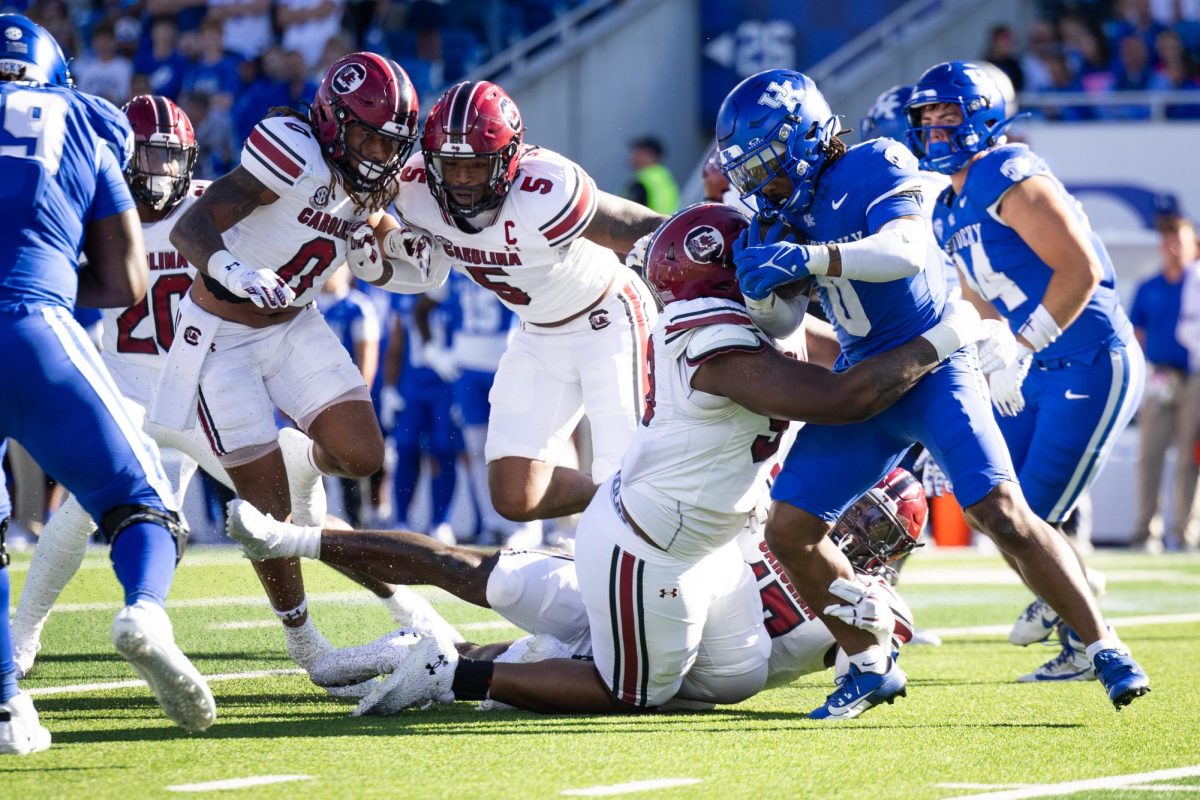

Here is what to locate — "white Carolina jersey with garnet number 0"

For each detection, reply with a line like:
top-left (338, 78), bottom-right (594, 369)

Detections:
top-left (223, 116), bottom-right (370, 308)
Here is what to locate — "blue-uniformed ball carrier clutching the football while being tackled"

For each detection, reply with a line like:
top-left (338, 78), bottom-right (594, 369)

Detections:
top-left (716, 70), bottom-right (1148, 720)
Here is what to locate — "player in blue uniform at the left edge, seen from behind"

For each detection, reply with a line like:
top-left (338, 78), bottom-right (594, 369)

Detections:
top-left (0, 14), bottom-right (216, 730)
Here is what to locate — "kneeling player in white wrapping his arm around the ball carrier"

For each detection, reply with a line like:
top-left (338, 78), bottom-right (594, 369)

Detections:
top-left (280, 204), bottom-right (983, 714)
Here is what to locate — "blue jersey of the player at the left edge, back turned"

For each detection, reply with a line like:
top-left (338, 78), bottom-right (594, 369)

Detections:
top-left (0, 83), bottom-right (133, 311)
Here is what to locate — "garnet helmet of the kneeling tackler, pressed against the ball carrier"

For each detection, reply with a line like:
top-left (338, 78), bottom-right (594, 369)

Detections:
top-left (646, 203), bottom-right (750, 305)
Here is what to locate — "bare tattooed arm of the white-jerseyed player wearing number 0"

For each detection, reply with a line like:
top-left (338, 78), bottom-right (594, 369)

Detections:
top-left (170, 167), bottom-right (278, 275)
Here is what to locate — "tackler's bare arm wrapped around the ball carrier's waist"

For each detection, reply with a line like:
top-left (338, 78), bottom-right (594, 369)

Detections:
top-left (692, 301), bottom-right (984, 425)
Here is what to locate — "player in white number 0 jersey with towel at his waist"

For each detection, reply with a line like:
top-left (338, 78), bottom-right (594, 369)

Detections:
top-left (150, 53), bottom-right (427, 666)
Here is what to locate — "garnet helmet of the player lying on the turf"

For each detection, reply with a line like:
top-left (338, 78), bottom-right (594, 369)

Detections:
top-left (829, 467), bottom-right (929, 575)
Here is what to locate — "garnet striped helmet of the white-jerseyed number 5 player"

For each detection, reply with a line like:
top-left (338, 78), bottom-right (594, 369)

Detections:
top-left (421, 80), bottom-right (524, 217)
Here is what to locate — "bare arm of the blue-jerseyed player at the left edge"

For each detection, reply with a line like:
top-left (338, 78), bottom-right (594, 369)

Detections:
top-left (76, 209), bottom-right (148, 308)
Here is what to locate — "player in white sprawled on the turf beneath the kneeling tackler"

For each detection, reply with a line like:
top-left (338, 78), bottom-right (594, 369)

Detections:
top-left (227, 468), bottom-right (928, 688)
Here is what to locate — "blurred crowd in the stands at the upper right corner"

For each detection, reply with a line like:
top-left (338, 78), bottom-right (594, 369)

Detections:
top-left (980, 0), bottom-right (1200, 121)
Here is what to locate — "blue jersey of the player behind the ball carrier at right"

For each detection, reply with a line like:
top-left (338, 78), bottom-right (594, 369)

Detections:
top-left (934, 144), bottom-right (1132, 360)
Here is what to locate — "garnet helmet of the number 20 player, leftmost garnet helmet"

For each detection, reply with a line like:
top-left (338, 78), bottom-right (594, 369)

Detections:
top-left (121, 95), bottom-right (197, 211)
